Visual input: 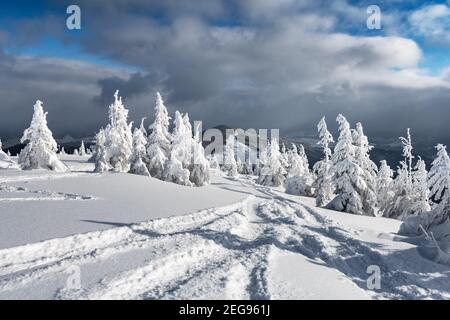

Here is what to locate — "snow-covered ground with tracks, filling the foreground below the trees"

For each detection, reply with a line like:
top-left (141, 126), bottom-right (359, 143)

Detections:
top-left (0, 156), bottom-right (450, 299)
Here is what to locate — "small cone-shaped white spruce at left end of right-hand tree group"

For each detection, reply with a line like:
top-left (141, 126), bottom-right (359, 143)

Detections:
top-left (258, 138), bottom-right (286, 187)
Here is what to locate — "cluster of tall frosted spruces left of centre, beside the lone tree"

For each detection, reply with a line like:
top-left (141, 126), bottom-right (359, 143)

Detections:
top-left (92, 91), bottom-right (210, 186)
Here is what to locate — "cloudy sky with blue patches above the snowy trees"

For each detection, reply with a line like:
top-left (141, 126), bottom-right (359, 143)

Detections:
top-left (0, 0), bottom-right (450, 149)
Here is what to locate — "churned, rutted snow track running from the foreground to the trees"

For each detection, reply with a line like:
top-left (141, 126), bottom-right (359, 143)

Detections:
top-left (0, 181), bottom-right (450, 299)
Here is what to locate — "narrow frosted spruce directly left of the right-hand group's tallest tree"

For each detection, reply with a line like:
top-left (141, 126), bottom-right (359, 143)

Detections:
top-left (313, 117), bottom-right (334, 207)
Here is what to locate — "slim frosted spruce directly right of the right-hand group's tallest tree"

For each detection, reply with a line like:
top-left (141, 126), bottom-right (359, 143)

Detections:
top-left (352, 122), bottom-right (378, 215)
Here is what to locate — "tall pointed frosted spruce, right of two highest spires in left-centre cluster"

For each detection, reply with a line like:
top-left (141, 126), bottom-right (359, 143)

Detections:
top-left (147, 92), bottom-right (171, 179)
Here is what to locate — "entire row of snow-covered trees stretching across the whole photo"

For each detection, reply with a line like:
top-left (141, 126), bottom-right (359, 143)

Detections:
top-left (6, 91), bottom-right (450, 233)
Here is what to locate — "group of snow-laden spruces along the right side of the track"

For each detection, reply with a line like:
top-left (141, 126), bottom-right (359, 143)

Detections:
top-left (241, 115), bottom-right (450, 233)
